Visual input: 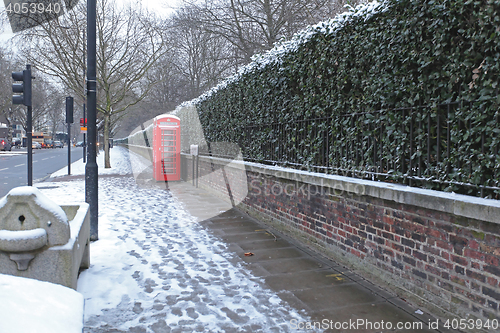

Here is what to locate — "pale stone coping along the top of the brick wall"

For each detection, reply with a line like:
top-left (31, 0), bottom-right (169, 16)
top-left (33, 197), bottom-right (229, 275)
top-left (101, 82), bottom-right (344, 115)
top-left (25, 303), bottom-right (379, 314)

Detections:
top-left (186, 154), bottom-right (500, 224)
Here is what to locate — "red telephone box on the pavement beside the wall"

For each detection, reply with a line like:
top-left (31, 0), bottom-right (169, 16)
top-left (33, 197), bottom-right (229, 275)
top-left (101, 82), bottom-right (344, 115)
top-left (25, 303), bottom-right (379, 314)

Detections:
top-left (153, 115), bottom-right (181, 181)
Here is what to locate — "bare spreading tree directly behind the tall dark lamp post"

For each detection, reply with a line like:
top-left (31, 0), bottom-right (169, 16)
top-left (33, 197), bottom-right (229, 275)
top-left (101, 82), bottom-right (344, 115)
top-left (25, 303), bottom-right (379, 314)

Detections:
top-left (14, 0), bottom-right (167, 168)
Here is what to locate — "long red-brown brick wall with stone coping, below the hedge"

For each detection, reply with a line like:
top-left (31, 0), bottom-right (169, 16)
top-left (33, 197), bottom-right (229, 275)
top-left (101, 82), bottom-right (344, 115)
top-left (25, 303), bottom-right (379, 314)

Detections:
top-left (184, 157), bottom-right (500, 326)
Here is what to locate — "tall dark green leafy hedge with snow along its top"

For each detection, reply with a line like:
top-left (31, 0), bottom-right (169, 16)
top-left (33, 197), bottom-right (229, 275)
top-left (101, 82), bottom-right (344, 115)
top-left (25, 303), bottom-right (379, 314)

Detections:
top-left (188, 0), bottom-right (500, 197)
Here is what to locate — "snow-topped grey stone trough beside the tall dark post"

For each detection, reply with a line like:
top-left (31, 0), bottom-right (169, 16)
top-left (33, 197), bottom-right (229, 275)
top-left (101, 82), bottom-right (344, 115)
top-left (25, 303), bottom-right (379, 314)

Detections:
top-left (0, 186), bottom-right (90, 289)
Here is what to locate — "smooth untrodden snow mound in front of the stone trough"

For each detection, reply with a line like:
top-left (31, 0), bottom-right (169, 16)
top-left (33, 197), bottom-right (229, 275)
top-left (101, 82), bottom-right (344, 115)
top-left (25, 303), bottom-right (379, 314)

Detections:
top-left (0, 274), bottom-right (83, 333)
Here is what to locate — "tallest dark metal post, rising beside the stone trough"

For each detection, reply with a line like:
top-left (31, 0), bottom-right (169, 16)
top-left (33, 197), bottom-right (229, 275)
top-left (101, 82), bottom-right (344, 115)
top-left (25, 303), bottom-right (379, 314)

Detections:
top-left (85, 0), bottom-right (99, 241)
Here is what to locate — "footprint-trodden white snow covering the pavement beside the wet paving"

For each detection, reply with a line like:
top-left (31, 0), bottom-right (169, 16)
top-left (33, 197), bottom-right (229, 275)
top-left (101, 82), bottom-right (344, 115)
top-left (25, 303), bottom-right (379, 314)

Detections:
top-left (39, 147), bottom-right (312, 333)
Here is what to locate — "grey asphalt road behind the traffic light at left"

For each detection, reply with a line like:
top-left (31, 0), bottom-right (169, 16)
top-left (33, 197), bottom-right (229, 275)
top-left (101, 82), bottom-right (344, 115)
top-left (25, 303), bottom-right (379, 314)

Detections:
top-left (0, 147), bottom-right (83, 198)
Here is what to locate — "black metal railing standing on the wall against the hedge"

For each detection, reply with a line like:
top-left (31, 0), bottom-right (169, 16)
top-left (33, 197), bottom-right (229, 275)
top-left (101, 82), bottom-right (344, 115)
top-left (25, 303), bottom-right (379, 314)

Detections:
top-left (205, 99), bottom-right (500, 199)
